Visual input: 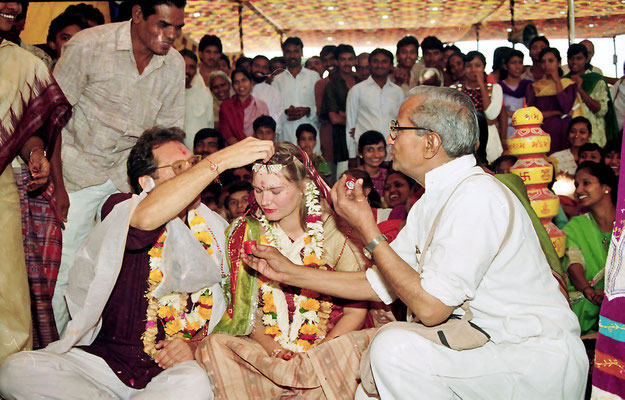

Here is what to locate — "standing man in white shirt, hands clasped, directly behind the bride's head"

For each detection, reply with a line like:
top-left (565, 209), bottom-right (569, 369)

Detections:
top-left (272, 37), bottom-right (321, 153)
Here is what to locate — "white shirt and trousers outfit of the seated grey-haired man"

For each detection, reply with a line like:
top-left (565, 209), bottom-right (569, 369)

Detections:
top-left (367, 155), bottom-right (588, 399)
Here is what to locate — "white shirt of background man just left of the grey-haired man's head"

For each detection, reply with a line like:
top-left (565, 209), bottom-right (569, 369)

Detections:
top-left (345, 77), bottom-right (404, 158)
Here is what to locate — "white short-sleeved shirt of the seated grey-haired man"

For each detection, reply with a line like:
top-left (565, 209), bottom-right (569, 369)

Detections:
top-left (367, 155), bottom-right (580, 343)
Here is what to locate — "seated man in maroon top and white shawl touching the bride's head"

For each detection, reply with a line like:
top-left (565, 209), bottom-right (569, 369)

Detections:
top-left (0, 127), bottom-right (273, 400)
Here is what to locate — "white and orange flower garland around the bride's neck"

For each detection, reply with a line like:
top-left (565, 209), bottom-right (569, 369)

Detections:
top-left (259, 181), bottom-right (332, 353)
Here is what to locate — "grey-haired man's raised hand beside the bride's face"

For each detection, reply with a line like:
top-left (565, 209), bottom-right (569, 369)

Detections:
top-left (330, 175), bottom-right (375, 230)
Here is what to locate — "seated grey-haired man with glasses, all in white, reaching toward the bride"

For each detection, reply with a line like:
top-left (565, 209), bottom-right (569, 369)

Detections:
top-left (243, 86), bottom-right (588, 399)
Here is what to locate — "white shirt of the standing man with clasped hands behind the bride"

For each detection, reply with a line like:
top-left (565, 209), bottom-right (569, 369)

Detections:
top-left (272, 68), bottom-right (321, 153)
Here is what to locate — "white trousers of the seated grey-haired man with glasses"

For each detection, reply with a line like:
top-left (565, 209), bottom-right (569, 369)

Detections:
top-left (356, 329), bottom-right (588, 400)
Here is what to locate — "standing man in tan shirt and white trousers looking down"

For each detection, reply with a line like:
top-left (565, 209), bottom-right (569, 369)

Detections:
top-left (52, 0), bottom-right (186, 335)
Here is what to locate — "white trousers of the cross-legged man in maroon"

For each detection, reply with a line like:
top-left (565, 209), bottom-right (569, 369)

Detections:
top-left (0, 348), bottom-right (213, 400)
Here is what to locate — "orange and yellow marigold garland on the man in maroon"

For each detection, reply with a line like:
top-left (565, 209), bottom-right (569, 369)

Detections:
top-left (141, 210), bottom-right (223, 358)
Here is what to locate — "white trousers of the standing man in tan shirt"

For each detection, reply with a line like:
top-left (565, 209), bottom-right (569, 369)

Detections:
top-left (52, 180), bottom-right (119, 337)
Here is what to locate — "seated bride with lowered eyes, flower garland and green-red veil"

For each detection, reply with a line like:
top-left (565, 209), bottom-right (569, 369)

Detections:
top-left (200, 142), bottom-right (367, 398)
